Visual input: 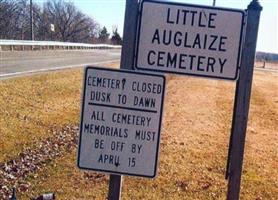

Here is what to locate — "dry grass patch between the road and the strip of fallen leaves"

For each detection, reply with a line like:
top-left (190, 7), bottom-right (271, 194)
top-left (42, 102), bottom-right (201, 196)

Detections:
top-left (0, 69), bottom-right (82, 162)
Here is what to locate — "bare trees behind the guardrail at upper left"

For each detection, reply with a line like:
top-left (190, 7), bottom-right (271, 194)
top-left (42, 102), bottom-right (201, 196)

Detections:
top-left (0, 0), bottom-right (122, 44)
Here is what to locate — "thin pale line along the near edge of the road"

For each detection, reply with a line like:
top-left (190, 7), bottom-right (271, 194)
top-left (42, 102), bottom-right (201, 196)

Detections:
top-left (0, 59), bottom-right (120, 79)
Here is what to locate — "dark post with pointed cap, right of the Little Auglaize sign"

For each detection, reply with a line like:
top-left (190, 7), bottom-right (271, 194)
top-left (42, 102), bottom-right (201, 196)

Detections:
top-left (227, 0), bottom-right (262, 200)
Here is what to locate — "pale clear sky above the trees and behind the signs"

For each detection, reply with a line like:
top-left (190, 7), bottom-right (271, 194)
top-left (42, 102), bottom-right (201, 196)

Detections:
top-left (37, 0), bottom-right (278, 53)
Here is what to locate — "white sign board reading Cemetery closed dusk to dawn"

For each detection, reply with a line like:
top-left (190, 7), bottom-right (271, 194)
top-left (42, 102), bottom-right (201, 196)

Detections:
top-left (78, 67), bottom-right (165, 178)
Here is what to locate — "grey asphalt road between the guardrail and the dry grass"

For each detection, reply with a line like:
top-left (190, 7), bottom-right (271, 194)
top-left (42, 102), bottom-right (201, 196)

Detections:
top-left (0, 49), bottom-right (121, 78)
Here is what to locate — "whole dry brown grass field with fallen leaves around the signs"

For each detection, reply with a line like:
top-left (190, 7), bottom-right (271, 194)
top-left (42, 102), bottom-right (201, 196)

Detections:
top-left (0, 63), bottom-right (278, 200)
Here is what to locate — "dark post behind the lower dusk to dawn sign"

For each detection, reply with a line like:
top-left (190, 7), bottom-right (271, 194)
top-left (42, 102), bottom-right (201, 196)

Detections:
top-left (108, 0), bottom-right (139, 200)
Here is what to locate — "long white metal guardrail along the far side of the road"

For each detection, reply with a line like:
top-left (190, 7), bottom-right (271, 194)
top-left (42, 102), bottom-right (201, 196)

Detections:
top-left (0, 40), bottom-right (122, 51)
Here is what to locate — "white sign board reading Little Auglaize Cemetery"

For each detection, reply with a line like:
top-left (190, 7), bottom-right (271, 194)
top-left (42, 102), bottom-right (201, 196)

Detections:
top-left (136, 0), bottom-right (245, 80)
